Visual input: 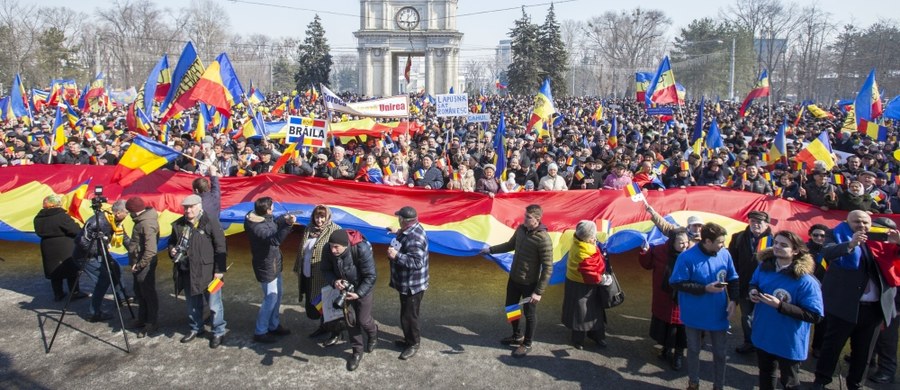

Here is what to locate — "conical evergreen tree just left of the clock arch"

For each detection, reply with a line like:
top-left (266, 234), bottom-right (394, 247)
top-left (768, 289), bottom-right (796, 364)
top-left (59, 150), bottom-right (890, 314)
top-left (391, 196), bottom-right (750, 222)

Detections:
top-left (294, 15), bottom-right (333, 91)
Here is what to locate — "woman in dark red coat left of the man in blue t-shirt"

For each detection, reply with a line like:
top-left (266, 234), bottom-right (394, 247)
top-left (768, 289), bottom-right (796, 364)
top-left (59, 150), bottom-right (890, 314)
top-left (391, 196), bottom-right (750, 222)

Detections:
top-left (638, 227), bottom-right (692, 370)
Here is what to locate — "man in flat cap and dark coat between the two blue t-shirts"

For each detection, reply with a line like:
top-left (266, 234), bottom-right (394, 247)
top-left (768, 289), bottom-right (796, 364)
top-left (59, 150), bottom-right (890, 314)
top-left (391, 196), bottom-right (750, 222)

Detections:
top-left (728, 210), bottom-right (772, 353)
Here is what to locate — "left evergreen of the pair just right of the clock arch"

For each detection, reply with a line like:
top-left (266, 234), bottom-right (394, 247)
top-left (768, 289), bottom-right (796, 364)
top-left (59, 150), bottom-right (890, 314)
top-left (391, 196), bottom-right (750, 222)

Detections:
top-left (507, 7), bottom-right (544, 95)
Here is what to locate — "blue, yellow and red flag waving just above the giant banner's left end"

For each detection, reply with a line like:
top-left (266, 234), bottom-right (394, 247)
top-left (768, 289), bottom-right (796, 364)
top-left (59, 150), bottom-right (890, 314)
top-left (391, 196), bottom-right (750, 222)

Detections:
top-left (111, 135), bottom-right (181, 187)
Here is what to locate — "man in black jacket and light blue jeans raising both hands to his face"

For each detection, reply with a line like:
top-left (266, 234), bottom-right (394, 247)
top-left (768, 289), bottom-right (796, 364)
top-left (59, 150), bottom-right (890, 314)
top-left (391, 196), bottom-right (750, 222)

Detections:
top-left (244, 196), bottom-right (297, 343)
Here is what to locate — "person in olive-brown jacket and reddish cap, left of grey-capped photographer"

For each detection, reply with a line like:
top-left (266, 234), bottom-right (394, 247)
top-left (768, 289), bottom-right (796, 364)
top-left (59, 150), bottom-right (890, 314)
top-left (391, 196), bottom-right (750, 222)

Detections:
top-left (125, 197), bottom-right (159, 337)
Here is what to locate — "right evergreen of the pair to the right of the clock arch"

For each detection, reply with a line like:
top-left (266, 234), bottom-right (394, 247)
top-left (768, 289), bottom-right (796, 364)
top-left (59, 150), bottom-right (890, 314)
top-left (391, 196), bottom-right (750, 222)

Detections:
top-left (537, 3), bottom-right (569, 96)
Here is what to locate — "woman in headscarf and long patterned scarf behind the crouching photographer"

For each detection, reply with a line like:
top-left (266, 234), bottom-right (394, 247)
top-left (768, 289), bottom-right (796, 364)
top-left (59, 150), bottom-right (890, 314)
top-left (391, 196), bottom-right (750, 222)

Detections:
top-left (294, 205), bottom-right (341, 337)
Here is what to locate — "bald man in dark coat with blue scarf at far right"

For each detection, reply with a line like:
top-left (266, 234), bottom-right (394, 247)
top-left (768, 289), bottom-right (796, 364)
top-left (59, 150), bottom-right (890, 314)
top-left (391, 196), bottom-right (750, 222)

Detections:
top-left (812, 210), bottom-right (900, 389)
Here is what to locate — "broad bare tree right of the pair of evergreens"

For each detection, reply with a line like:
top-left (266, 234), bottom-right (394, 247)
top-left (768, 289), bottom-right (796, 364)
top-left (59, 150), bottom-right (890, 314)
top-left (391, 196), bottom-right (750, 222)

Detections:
top-left (587, 7), bottom-right (672, 95)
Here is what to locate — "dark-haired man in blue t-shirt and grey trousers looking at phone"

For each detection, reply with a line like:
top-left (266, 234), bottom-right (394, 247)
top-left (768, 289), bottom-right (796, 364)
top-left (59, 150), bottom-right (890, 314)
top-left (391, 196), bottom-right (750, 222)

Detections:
top-left (669, 222), bottom-right (738, 390)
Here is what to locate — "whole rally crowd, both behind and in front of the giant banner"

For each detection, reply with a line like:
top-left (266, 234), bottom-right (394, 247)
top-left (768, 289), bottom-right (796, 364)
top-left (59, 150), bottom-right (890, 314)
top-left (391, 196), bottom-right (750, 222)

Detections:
top-left (14, 88), bottom-right (900, 389)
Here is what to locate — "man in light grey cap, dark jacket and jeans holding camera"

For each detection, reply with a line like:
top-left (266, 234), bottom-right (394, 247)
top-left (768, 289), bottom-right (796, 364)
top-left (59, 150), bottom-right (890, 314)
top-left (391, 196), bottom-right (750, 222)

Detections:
top-left (169, 195), bottom-right (227, 348)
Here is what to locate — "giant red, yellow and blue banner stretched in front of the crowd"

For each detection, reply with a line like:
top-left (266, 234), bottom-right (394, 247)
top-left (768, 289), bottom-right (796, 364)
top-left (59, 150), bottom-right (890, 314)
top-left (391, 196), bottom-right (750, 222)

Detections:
top-left (0, 165), bottom-right (864, 283)
